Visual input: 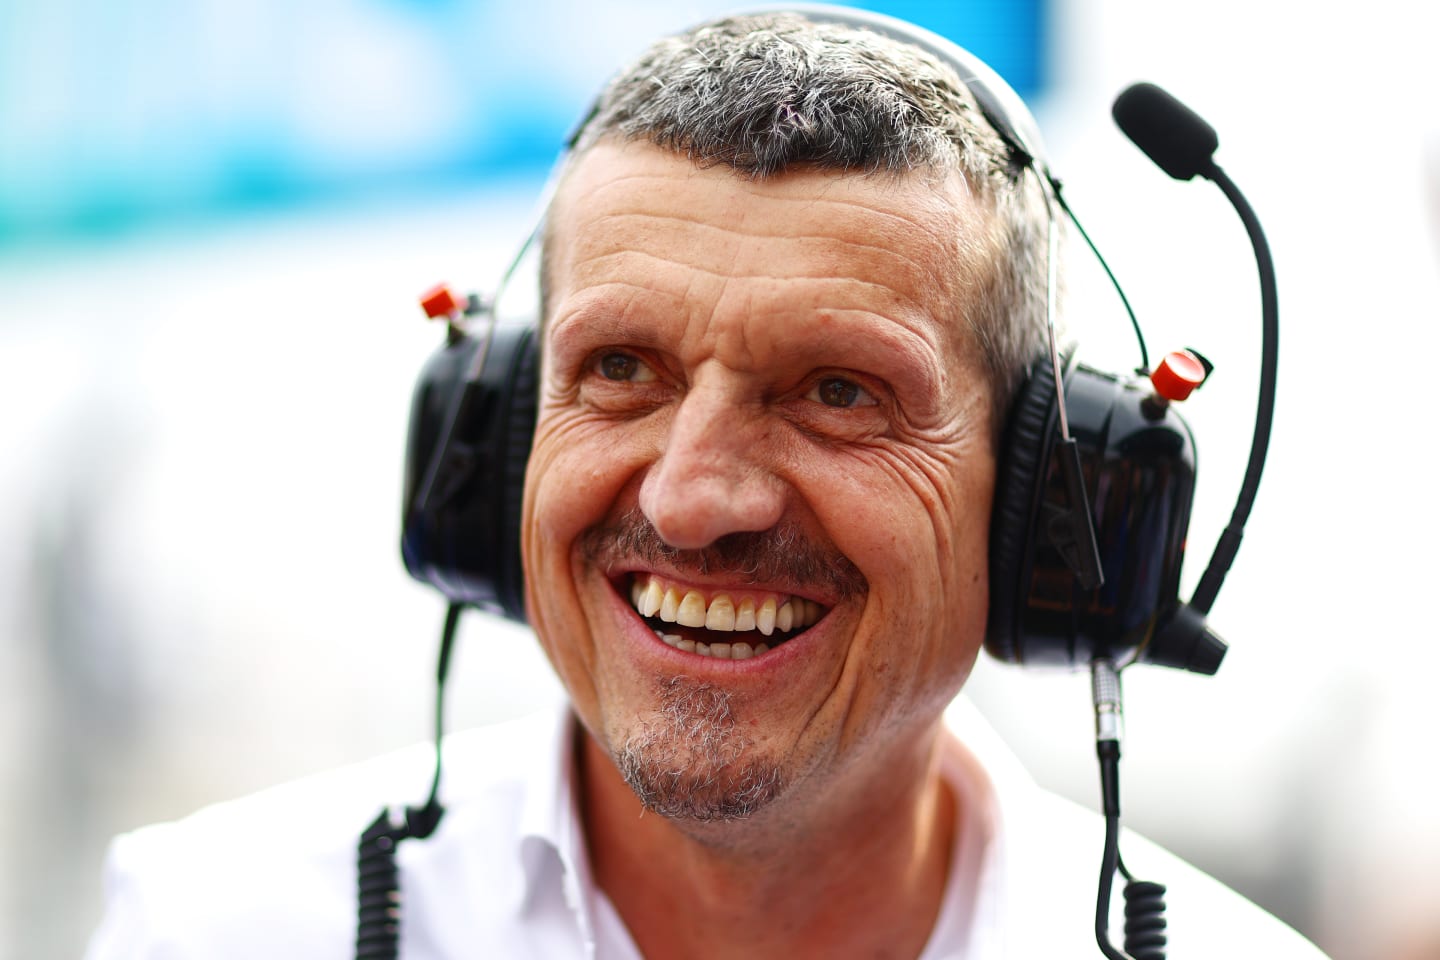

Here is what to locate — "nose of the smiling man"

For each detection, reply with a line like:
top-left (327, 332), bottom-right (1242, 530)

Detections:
top-left (639, 384), bottom-right (785, 550)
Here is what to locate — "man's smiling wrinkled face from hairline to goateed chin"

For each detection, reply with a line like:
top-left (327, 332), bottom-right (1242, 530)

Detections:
top-left (521, 142), bottom-right (995, 820)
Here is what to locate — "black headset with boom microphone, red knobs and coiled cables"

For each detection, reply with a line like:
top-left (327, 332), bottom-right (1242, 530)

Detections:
top-left (374, 6), bottom-right (1279, 960)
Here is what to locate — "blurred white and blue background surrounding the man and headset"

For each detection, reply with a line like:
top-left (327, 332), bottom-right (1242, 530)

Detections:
top-left (0, 0), bottom-right (1440, 960)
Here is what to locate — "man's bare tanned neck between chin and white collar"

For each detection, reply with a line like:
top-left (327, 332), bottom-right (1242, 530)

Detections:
top-left (579, 727), bottom-right (955, 960)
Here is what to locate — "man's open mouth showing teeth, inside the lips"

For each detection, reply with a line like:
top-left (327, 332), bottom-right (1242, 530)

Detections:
top-left (629, 573), bottom-right (829, 661)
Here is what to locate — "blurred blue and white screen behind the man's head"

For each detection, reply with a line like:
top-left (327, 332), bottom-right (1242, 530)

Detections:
top-left (0, 0), bottom-right (1045, 246)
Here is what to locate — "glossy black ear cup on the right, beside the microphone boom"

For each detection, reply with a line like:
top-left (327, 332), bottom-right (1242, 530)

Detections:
top-left (985, 357), bottom-right (1195, 668)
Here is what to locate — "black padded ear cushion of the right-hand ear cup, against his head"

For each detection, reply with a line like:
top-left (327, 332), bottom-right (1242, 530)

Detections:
top-left (985, 354), bottom-right (1056, 664)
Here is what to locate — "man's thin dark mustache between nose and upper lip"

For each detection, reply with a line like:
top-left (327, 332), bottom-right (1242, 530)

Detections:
top-left (580, 507), bottom-right (870, 600)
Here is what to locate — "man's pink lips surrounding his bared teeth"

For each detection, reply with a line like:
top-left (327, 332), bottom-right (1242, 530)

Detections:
top-left (605, 567), bottom-right (834, 679)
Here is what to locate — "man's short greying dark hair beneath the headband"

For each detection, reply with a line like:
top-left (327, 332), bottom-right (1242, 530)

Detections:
top-left (541, 13), bottom-right (1048, 432)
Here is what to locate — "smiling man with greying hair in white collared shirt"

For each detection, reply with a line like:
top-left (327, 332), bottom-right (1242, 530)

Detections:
top-left (92, 9), bottom-right (1316, 960)
